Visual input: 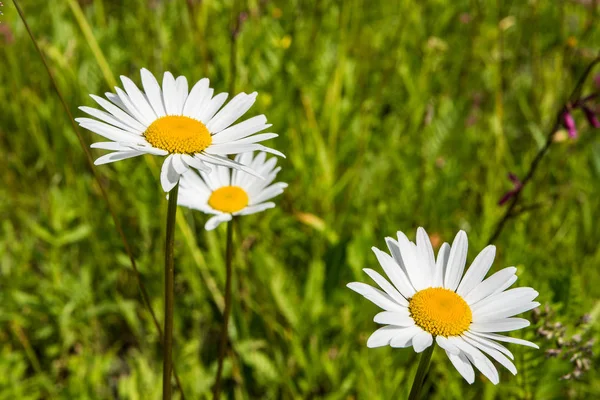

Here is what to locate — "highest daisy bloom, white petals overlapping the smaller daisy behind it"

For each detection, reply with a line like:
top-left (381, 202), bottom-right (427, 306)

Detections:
top-left (76, 68), bottom-right (284, 192)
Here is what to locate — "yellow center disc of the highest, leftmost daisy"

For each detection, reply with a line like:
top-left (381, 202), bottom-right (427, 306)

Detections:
top-left (144, 115), bottom-right (212, 154)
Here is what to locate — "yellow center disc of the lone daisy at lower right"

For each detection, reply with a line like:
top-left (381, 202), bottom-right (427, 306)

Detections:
top-left (408, 288), bottom-right (473, 337)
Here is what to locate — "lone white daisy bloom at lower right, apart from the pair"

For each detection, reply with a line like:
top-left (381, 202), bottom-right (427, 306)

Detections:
top-left (348, 228), bottom-right (539, 384)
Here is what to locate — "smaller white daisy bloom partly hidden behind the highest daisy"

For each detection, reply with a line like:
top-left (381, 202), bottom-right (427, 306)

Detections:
top-left (177, 152), bottom-right (287, 230)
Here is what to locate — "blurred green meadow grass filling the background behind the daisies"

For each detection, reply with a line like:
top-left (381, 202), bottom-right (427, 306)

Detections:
top-left (0, 0), bottom-right (600, 400)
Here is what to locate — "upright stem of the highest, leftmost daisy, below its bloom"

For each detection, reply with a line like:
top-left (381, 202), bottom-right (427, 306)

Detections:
top-left (163, 182), bottom-right (179, 400)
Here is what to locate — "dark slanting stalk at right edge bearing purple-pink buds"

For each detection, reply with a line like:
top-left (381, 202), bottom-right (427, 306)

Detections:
top-left (488, 56), bottom-right (600, 243)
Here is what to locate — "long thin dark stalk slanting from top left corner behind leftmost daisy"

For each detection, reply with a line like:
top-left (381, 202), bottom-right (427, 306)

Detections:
top-left (13, 0), bottom-right (185, 400)
